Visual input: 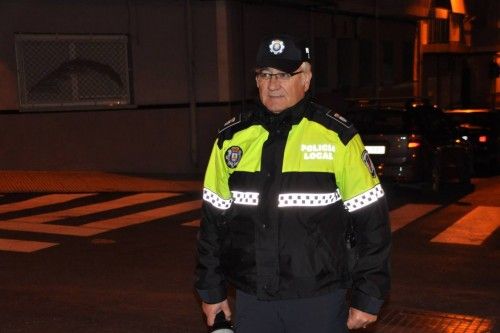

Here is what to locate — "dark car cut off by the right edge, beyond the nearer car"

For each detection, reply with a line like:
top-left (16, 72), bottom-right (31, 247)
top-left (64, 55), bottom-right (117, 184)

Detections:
top-left (445, 109), bottom-right (500, 173)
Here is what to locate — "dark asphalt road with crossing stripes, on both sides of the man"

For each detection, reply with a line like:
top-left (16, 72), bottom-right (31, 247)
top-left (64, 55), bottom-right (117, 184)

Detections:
top-left (0, 176), bottom-right (500, 333)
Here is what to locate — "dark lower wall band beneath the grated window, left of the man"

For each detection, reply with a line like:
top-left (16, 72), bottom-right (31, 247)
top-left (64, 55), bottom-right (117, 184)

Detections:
top-left (0, 108), bottom-right (228, 174)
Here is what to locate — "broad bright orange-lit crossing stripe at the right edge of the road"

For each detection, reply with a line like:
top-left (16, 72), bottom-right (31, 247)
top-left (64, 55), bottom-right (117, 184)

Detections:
top-left (431, 206), bottom-right (500, 245)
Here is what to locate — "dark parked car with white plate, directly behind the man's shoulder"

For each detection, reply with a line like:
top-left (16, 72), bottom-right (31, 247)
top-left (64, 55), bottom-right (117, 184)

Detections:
top-left (346, 103), bottom-right (472, 190)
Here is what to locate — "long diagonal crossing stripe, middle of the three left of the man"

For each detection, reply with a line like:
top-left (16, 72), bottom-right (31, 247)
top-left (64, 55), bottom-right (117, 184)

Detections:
top-left (0, 192), bottom-right (179, 223)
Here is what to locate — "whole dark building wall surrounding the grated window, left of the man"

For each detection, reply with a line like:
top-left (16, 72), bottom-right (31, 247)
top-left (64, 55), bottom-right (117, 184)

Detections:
top-left (0, 0), bottom-right (227, 173)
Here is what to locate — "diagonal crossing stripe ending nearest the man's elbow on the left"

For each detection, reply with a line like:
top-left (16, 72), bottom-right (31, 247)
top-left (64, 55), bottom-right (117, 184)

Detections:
top-left (80, 200), bottom-right (201, 232)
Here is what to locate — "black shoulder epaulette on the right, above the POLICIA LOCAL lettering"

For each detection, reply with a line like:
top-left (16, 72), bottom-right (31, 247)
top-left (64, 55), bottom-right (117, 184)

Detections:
top-left (310, 102), bottom-right (358, 145)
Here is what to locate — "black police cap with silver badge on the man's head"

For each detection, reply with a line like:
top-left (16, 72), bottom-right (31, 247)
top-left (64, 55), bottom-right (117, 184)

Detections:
top-left (256, 34), bottom-right (311, 73)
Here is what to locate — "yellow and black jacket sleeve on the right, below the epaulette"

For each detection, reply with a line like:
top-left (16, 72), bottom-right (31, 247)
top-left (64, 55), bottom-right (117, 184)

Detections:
top-left (337, 135), bottom-right (391, 314)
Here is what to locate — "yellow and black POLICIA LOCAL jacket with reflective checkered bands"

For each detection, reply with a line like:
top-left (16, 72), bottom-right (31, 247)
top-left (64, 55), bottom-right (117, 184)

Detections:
top-left (195, 99), bottom-right (391, 314)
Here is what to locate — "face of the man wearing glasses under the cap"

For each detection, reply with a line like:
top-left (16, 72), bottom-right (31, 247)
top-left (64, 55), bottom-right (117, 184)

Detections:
top-left (255, 66), bottom-right (312, 113)
